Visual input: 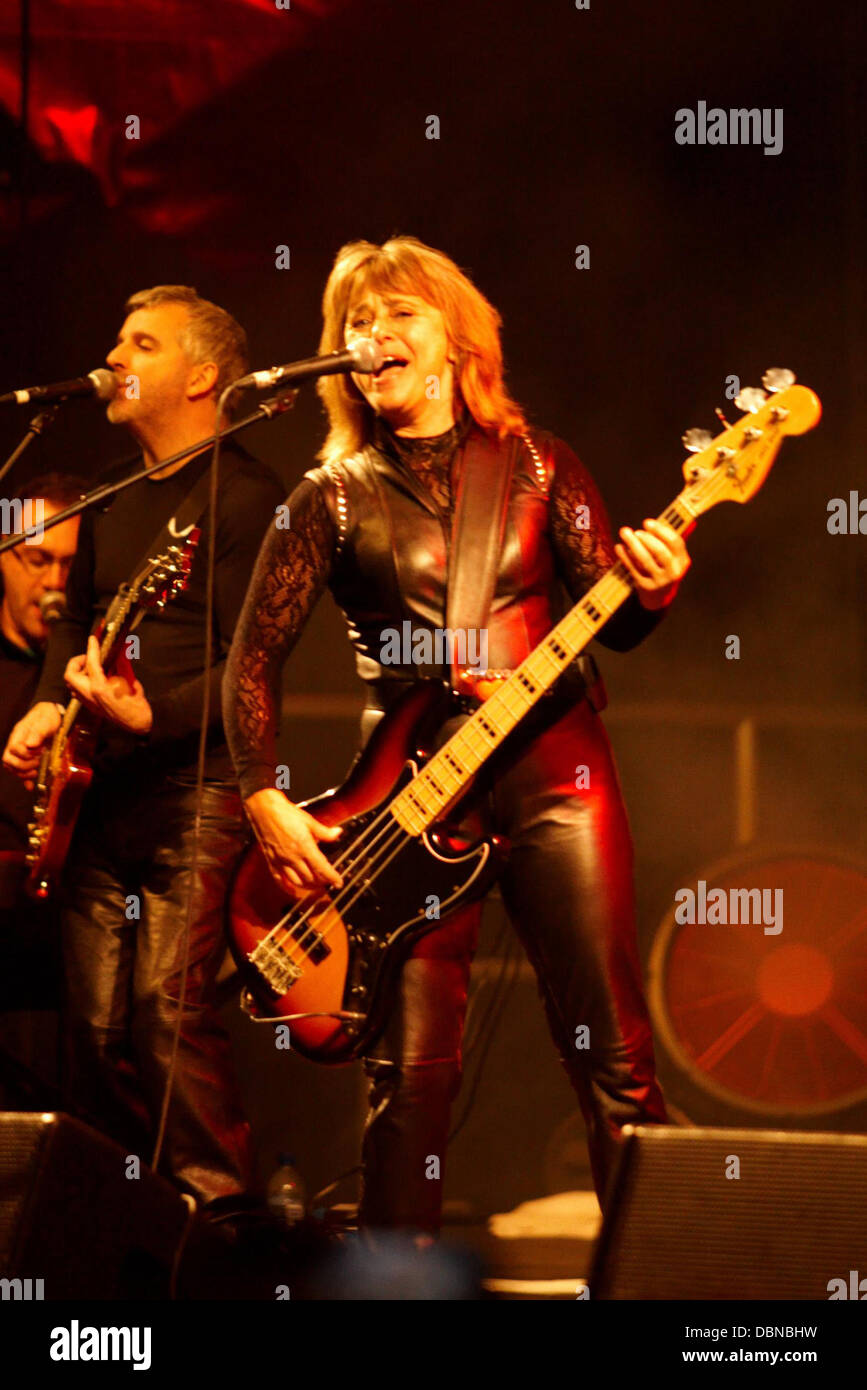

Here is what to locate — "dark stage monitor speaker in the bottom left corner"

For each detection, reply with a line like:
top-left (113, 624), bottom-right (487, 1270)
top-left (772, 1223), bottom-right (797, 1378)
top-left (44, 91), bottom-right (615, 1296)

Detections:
top-left (0, 1112), bottom-right (190, 1300)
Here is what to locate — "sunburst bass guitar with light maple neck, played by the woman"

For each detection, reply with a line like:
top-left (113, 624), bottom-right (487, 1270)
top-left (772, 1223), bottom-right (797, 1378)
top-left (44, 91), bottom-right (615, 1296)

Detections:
top-left (226, 368), bottom-right (821, 1063)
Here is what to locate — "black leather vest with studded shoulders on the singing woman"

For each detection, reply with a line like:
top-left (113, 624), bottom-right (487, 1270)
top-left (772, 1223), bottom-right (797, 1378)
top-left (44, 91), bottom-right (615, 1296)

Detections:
top-left (306, 425), bottom-right (591, 706)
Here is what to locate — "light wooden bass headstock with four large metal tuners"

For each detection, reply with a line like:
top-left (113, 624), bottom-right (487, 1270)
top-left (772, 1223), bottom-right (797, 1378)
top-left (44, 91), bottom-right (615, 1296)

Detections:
top-left (678, 367), bottom-right (821, 517)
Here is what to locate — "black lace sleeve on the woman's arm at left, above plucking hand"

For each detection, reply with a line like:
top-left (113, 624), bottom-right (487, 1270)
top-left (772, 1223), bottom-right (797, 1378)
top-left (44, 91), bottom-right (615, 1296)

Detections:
top-left (222, 480), bottom-right (335, 798)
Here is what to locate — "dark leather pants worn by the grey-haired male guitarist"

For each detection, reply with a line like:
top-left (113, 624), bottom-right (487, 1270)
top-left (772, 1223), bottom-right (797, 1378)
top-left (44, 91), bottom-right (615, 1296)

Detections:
top-left (63, 778), bottom-right (254, 1202)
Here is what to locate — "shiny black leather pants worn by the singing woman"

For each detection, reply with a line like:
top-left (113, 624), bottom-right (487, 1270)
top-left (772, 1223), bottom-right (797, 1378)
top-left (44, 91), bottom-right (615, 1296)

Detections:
top-left (361, 696), bottom-right (666, 1232)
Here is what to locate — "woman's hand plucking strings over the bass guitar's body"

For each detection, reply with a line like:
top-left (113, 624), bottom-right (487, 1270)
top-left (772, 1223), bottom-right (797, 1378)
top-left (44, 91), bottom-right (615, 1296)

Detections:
top-left (245, 787), bottom-right (343, 898)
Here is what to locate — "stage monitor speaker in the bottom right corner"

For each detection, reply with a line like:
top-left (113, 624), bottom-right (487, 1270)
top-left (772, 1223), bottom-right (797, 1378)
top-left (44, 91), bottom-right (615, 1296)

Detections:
top-left (589, 1126), bottom-right (867, 1300)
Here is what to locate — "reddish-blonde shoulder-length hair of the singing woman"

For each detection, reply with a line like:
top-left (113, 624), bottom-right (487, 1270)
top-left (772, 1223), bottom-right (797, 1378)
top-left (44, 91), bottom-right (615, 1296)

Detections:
top-left (317, 236), bottom-right (527, 463)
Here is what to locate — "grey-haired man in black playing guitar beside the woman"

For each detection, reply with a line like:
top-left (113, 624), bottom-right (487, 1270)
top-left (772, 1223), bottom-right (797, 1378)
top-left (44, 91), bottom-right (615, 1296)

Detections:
top-left (3, 285), bottom-right (282, 1215)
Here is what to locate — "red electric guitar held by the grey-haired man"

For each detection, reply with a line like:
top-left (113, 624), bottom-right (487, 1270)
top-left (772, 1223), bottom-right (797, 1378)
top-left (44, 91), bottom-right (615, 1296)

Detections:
top-left (25, 527), bottom-right (201, 898)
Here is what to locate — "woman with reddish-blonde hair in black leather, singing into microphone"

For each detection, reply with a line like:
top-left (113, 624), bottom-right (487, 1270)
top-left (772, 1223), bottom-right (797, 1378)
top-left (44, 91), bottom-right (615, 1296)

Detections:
top-left (224, 238), bottom-right (689, 1240)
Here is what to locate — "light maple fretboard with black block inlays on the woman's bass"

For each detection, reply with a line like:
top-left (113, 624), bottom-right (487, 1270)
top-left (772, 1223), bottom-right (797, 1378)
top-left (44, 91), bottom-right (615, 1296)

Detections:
top-left (389, 492), bottom-right (696, 835)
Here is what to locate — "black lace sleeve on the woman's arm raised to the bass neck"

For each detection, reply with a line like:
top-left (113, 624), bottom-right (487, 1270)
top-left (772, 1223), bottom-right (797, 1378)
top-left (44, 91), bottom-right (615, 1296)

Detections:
top-left (550, 439), bottom-right (664, 652)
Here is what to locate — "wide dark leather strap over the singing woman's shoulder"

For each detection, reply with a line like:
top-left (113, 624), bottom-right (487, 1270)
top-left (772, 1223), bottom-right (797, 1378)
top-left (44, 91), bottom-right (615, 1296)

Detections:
top-left (446, 428), bottom-right (521, 689)
